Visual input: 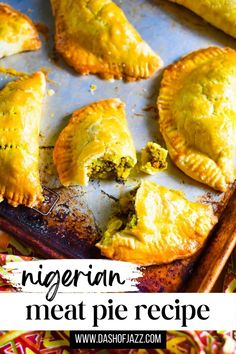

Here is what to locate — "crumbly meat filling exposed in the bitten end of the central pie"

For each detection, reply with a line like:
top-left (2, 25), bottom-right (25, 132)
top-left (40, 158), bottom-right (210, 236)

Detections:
top-left (88, 156), bottom-right (134, 181)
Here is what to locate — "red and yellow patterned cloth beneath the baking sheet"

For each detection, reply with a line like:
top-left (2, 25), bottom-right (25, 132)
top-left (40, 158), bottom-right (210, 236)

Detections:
top-left (0, 231), bottom-right (236, 354)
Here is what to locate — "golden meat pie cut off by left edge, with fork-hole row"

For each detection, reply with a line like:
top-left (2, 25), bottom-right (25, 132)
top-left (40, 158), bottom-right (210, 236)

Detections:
top-left (0, 72), bottom-right (46, 207)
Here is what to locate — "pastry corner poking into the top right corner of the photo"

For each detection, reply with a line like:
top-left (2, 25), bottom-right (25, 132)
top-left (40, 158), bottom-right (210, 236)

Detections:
top-left (170, 0), bottom-right (236, 38)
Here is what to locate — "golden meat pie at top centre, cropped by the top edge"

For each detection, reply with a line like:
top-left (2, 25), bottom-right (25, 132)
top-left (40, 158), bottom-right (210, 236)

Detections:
top-left (51, 0), bottom-right (161, 80)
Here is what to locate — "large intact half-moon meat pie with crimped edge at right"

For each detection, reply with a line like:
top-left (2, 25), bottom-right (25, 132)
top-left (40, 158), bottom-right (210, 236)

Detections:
top-left (158, 47), bottom-right (236, 192)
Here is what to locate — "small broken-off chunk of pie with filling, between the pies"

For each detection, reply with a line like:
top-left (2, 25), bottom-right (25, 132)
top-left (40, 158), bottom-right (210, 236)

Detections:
top-left (140, 142), bottom-right (168, 174)
